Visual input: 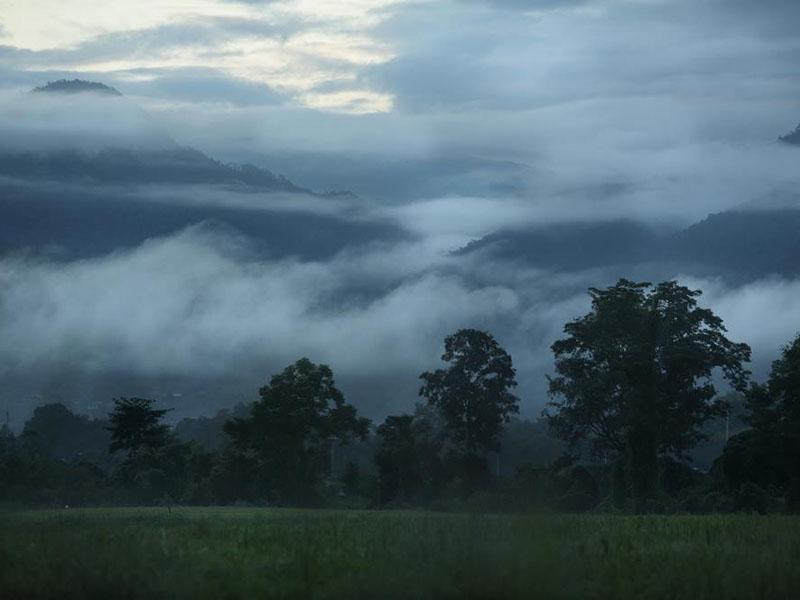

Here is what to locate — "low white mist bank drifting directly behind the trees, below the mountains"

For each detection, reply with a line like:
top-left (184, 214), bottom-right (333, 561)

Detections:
top-left (0, 206), bottom-right (800, 418)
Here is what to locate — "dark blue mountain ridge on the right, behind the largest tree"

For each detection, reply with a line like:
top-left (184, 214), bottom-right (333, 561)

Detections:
top-left (457, 208), bottom-right (800, 282)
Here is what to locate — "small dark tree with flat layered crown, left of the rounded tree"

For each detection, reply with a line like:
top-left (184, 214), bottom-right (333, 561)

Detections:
top-left (108, 398), bottom-right (169, 458)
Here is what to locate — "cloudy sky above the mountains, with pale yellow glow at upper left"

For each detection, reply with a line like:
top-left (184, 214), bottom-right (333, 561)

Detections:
top-left (6, 0), bottom-right (800, 206)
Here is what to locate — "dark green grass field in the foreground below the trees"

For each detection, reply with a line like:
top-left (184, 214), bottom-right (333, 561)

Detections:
top-left (0, 508), bottom-right (800, 600)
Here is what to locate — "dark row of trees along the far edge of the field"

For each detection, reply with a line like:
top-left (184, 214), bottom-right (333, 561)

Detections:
top-left (0, 279), bottom-right (800, 513)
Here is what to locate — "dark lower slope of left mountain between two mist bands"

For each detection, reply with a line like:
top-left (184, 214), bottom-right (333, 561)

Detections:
top-left (0, 178), bottom-right (406, 260)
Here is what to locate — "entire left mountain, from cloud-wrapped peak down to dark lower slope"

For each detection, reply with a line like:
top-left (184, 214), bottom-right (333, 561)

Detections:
top-left (0, 80), bottom-right (396, 259)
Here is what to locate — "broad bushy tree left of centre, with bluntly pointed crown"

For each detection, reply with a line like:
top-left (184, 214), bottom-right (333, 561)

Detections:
top-left (225, 358), bottom-right (369, 503)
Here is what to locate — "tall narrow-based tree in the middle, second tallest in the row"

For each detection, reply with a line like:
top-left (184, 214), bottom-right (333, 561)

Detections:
top-left (419, 329), bottom-right (519, 486)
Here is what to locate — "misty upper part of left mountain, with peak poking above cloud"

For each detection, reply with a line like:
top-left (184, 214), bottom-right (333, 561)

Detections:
top-left (0, 79), bottom-right (311, 193)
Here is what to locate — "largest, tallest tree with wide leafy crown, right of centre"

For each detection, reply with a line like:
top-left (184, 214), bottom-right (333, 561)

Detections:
top-left (546, 279), bottom-right (750, 511)
